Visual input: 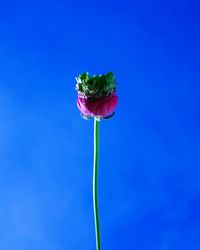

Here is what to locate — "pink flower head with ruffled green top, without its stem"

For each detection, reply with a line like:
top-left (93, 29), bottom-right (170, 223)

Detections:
top-left (76, 72), bottom-right (118, 119)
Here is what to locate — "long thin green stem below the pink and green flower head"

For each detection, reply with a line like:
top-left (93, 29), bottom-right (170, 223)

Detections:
top-left (93, 117), bottom-right (101, 250)
